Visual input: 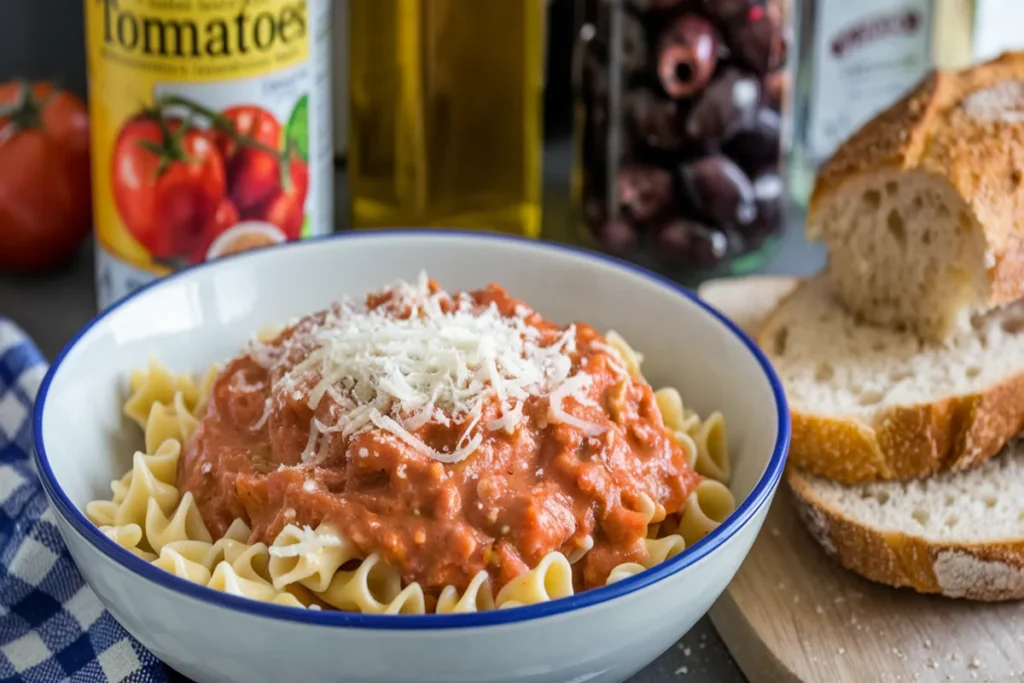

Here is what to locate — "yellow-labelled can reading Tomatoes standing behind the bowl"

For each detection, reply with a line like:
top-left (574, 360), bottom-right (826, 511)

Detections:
top-left (85, 0), bottom-right (333, 308)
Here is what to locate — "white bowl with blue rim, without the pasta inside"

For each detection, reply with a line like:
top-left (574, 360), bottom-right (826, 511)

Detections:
top-left (29, 229), bottom-right (790, 683)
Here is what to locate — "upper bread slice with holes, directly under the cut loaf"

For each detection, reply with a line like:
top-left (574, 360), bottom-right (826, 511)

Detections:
top-left (758, 274), bottom-right (1024, 483)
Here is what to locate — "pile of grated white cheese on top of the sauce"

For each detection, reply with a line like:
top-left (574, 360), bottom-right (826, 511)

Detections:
top-left (250, 273), bottom-right (603, 463)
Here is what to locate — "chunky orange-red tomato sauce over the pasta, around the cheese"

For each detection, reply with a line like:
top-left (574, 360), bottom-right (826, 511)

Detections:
top-left (178, 285), bottom-right (699, 595)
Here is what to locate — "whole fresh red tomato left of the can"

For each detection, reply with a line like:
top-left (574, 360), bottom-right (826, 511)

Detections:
top-left (0, 83), bottom-right (92, 270)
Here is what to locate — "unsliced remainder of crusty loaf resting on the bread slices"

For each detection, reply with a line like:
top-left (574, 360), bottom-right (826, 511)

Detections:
top-left (807, 52), bottom-right (1024, 339)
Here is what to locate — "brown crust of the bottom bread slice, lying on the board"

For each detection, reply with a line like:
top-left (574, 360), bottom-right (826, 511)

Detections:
top-left (785, 465), bottom-right (1024, 601)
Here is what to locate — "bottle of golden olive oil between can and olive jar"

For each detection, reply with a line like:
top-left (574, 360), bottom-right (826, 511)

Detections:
top-left (348, 0), bottom-right (546, 237)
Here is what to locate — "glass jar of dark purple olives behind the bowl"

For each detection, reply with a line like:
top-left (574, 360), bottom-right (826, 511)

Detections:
top-left (573, 0), bottom-right (790, 283)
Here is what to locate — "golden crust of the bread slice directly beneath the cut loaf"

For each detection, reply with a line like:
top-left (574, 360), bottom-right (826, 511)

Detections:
top-left (757, 281), bottom-right (1024, 484)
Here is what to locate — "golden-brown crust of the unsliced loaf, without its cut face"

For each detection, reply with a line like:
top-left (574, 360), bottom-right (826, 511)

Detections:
top-left (807, 52), bottom-right (1024, 306)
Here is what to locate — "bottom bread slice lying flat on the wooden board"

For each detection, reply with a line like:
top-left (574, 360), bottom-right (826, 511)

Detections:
top-left (786, 448), bottom-right (1024, 600)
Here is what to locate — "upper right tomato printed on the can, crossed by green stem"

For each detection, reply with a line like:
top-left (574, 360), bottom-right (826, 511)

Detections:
top-left (216, 104), bottom-right (281, 215)
